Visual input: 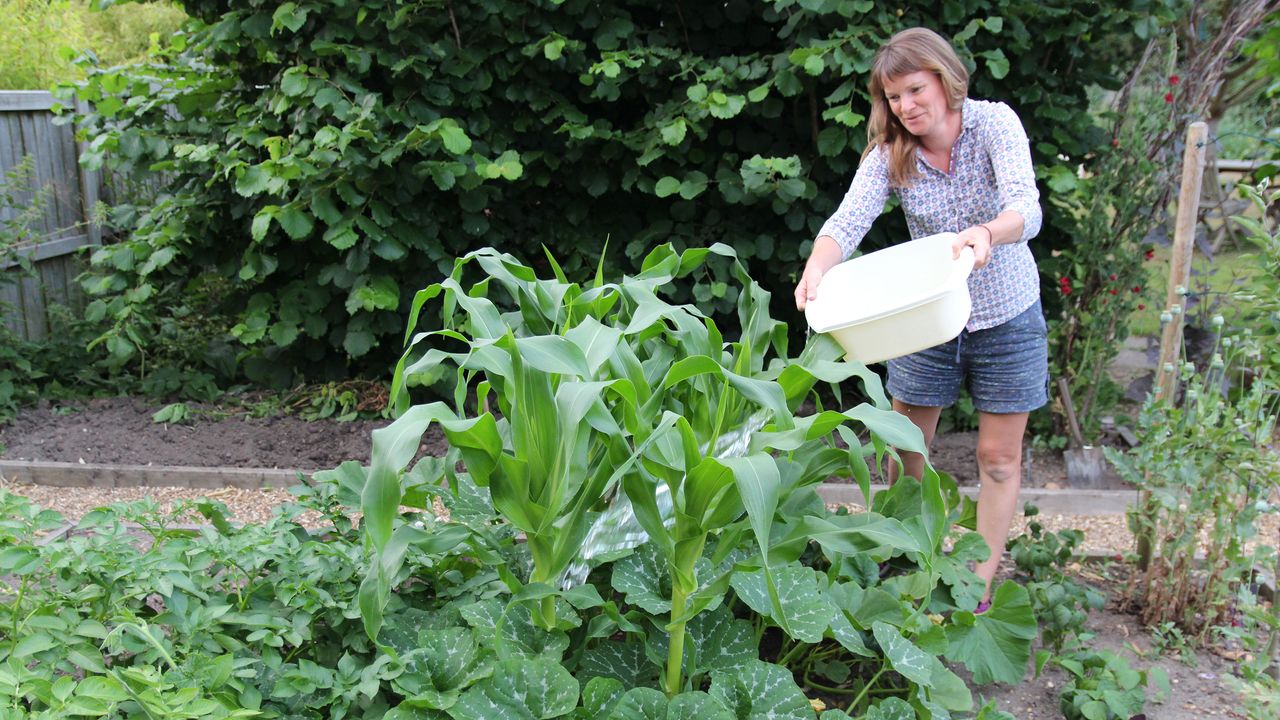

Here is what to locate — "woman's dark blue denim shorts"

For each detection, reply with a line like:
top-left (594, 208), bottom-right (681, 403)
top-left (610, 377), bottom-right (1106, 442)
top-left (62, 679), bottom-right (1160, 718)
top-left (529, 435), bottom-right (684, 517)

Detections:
top-left (886, 300), bottom-right (1048, 414)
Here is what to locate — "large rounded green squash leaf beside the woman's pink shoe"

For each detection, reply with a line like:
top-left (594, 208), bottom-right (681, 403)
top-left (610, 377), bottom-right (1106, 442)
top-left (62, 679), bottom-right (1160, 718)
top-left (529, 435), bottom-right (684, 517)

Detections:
top-left (946, 582), bottom-right (1036, 684)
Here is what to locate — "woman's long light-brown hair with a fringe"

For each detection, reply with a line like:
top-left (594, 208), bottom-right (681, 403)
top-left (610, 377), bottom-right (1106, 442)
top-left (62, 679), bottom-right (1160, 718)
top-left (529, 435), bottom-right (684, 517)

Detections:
top-left (863, 27), bottom-right (969, 187)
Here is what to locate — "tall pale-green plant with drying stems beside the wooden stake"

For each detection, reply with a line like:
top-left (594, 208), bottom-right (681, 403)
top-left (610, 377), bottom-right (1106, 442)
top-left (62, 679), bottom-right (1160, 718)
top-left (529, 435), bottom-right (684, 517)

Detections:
top-left (1107, 327), bottom-right (1280, 630)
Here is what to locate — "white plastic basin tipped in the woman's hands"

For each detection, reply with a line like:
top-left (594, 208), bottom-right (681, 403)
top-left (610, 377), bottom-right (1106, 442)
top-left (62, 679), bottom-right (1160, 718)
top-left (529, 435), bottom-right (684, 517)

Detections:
top-left (805, 233), bottom-right (973, 363)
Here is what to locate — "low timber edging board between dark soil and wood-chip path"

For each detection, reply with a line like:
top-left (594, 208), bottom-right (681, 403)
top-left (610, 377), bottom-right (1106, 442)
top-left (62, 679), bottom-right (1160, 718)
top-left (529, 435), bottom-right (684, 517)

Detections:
top-left (0, 460), bottom-right (1138, 515)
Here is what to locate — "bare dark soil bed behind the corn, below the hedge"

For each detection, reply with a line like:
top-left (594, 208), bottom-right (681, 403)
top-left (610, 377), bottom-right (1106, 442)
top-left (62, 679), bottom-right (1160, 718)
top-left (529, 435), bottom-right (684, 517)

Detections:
top-left (0, 397), bottom-right (1066, 488)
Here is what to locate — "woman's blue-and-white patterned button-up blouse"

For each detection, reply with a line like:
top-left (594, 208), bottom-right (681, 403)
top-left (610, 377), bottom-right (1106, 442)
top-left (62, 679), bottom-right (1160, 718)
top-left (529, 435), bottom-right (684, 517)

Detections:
top-left (819, 99), bottom-right (1042, 332)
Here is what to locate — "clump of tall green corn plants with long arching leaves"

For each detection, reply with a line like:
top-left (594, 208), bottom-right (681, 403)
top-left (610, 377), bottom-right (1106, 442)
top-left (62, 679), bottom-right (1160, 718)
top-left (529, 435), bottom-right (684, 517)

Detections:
top-left (361, 239), bottom-right (1025, 707)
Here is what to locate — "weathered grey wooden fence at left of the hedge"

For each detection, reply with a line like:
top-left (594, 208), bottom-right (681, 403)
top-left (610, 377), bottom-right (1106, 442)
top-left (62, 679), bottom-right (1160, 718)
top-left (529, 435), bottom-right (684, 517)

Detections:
top-left (0, 91), bottom-right (101, 340)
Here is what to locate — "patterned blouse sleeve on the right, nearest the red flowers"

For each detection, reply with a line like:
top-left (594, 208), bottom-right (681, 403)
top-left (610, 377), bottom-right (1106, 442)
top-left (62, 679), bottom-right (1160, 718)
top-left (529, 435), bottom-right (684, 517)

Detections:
top-left (983, 102), bottom-right (1043, 242)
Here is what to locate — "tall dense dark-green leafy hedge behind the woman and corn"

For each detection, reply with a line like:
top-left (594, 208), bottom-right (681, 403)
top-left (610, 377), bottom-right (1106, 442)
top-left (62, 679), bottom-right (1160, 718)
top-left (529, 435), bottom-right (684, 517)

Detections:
top-left (68, 0), bottom-right (1166, 382)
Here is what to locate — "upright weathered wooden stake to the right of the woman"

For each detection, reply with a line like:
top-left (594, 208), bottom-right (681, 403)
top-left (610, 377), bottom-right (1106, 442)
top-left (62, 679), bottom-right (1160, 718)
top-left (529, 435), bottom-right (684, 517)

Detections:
top-left (1135, 122), bottom-right (1208, 570)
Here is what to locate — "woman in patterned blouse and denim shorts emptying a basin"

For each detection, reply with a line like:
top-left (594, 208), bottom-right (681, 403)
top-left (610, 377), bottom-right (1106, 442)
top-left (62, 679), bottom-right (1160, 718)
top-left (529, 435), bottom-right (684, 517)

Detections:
top-left (795, 28), bottom-right (1048, 612)
